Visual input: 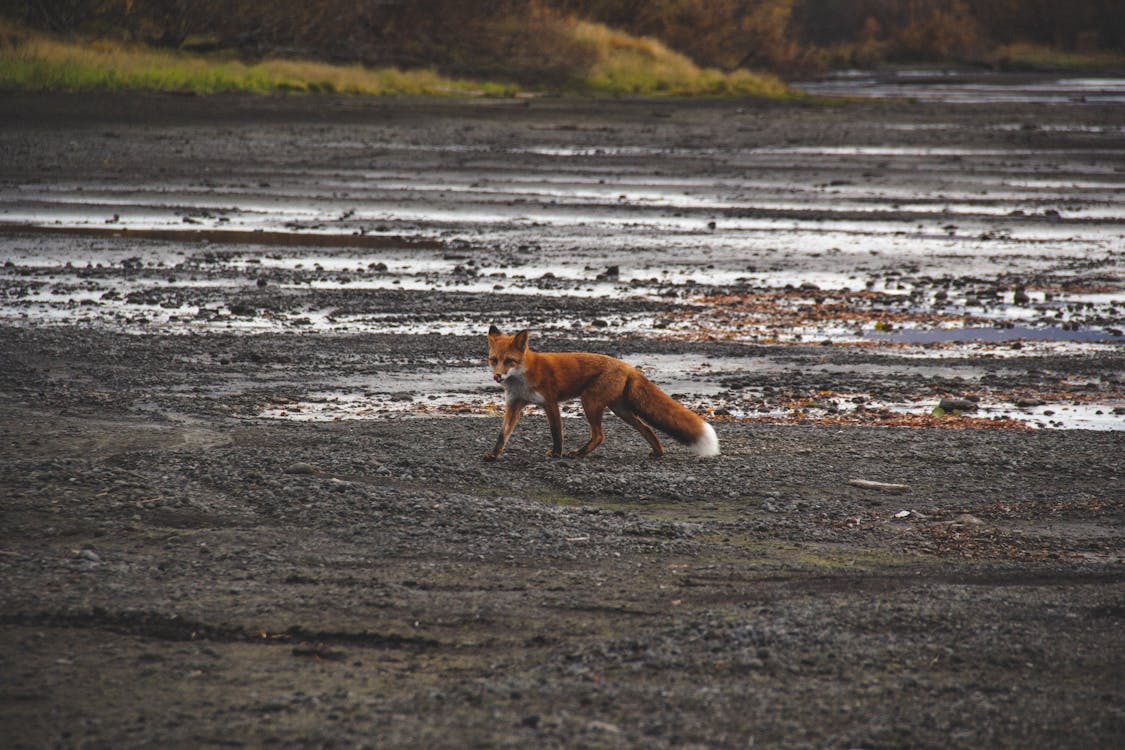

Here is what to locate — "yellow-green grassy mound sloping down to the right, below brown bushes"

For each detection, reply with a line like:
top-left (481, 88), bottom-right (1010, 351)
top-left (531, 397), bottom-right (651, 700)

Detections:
top-left (568, 20), bottom-right (799, 99)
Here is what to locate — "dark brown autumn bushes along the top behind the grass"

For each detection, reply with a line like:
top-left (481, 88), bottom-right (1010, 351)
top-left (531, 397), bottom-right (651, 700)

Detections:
top-left (7, 0), bottom-right (1125, 83)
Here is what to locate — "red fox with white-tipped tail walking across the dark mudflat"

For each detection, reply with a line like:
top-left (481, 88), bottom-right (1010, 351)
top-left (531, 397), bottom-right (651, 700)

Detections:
top-left (485, 326), bottom-right (719, 460)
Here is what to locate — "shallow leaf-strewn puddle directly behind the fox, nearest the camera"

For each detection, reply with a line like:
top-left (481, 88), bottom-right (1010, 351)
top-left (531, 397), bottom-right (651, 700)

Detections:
top-left (248, 354), bottom-right (1125, 431)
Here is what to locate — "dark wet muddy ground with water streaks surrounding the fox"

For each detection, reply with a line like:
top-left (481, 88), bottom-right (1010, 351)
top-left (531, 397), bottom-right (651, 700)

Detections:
top-left (0, 94), bottom-right (1125, 748)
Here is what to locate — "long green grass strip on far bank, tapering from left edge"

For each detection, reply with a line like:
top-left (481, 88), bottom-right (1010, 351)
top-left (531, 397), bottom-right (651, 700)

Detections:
top-left (0, 21), bottom-right (516, 96)
